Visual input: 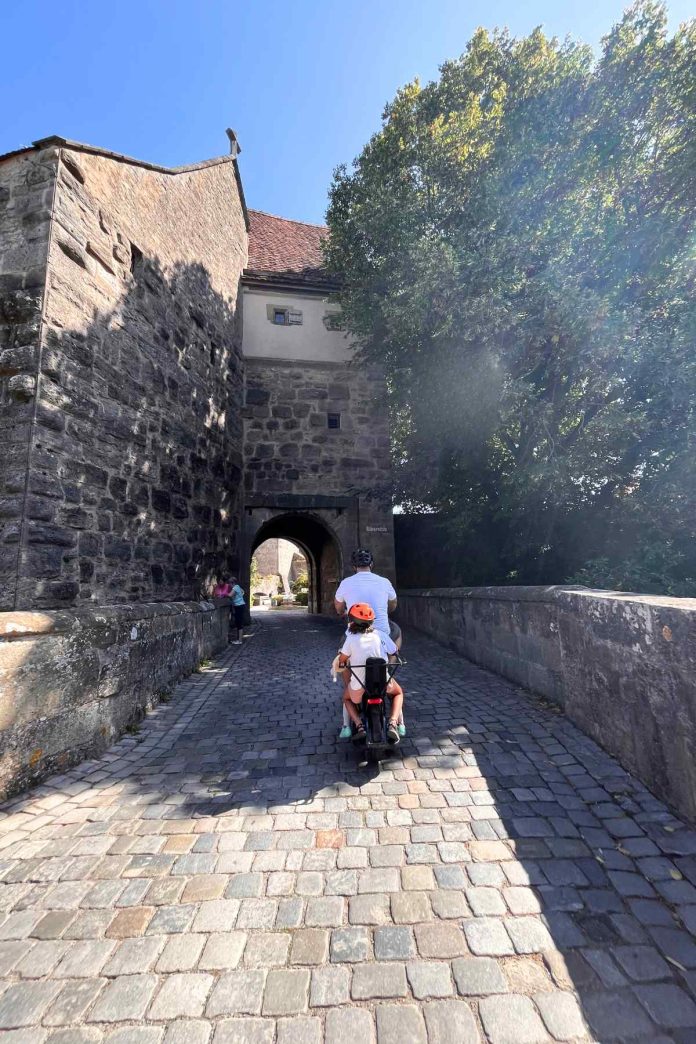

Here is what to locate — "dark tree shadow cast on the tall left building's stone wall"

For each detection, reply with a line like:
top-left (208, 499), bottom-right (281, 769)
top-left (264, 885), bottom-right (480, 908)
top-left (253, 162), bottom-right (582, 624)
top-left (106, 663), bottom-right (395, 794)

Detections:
top-left (18, 247), bottom-right (247, 609)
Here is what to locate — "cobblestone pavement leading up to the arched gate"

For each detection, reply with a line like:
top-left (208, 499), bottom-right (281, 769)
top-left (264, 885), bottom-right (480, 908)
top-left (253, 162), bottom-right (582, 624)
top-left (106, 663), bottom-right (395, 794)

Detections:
top-left (0, 614), bottom-right (696, 1044)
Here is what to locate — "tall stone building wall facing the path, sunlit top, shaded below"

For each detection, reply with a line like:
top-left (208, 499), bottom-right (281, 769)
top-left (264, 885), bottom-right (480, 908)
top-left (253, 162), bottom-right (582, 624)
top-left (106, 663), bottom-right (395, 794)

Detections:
top-left (2, 145), bottom-right (246, 609)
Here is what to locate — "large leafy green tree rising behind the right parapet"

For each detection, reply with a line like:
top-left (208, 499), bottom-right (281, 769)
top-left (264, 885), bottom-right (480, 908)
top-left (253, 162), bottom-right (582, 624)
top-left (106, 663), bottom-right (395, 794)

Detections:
top-left (327, 0), bottom-right (696, 594)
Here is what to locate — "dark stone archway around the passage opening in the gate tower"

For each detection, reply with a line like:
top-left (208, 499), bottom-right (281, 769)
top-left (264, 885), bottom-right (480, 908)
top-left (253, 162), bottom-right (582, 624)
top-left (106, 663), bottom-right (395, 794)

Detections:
top-left (244, 511), bottom-right (343, 614)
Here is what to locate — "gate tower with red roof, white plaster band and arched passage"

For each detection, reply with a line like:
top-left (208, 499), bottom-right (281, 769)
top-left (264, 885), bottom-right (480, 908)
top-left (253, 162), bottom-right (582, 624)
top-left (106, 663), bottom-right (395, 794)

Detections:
top-left (242, 210), bottom-right (393, 612)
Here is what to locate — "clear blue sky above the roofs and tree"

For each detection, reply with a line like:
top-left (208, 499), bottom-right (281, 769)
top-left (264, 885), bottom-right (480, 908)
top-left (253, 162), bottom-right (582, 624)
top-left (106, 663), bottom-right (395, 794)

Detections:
top-left (0, 0), bottom-right (693, 221)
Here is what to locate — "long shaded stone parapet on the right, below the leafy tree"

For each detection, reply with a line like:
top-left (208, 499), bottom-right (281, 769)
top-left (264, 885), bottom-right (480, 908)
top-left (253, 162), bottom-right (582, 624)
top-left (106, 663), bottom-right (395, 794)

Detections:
top-left (399, 587), bottom-right (696, 820)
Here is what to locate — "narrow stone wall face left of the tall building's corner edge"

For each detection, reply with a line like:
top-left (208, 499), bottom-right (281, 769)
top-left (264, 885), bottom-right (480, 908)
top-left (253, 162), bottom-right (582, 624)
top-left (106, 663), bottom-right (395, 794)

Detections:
top-left (0, 148), bottom-right (57, 609)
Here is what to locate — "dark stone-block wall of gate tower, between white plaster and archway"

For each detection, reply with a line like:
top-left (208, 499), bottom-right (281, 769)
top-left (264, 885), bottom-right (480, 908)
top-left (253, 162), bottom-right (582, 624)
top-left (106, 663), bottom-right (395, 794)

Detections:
top-left (244, 358), bottom-right (393, 576)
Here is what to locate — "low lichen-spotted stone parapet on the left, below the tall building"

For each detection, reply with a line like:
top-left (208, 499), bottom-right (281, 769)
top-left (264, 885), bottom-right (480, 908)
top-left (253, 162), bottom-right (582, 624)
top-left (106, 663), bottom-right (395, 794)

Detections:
top-left (0, 600), bottom-right (230, 799)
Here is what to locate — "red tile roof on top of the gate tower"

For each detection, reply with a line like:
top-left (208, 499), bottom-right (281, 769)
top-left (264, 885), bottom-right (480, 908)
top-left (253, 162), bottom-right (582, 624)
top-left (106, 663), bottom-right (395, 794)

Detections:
top-left (246, 210), bottom-right (332, 286)
